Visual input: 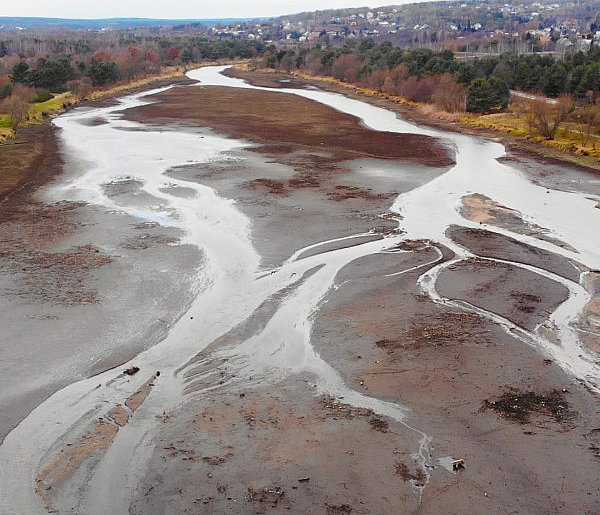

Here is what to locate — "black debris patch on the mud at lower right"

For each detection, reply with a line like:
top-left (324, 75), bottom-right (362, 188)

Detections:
top-left (482, 389), bottom-right (575, 424)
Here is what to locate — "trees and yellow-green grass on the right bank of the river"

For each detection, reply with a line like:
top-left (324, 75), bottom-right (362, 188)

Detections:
top-left (253, 40), bottom-right (600, 163)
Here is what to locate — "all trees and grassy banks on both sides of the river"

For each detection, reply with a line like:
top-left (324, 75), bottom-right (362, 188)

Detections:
top-left (0, 24), bottom-right (600, 165)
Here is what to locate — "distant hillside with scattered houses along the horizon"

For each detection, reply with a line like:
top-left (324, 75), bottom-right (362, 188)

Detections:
top-left (0, 0), bottom-right (600, 54)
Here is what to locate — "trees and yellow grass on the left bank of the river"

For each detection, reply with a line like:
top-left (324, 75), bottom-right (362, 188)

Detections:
top-left (0, 37), bottom-right (265, 142)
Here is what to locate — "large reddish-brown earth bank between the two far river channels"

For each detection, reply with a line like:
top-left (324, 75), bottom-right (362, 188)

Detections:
top-left (126, 86), bottom-right (453, 167)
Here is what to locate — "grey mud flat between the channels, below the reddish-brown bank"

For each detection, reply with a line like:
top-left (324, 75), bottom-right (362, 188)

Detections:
top-left (168, 144), bottom-right (432, 268)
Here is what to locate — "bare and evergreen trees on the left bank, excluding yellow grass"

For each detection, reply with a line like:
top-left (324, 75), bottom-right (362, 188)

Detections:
top-left (0, 37), bottom-right (266, 131)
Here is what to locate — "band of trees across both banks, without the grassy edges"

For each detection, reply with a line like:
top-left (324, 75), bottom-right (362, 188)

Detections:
top-left (0, 32), bottom-right (600, 144)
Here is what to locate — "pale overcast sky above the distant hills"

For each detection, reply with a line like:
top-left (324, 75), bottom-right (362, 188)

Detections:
top-left (0, 0), bottom-right (434, 19)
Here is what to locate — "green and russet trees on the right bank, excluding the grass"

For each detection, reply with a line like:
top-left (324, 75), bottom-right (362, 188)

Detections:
top-left (262, 39), bottom-right (600, 113)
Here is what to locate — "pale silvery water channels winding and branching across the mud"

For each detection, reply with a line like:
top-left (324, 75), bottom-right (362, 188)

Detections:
top-left (0, 67), bottom-right (600, 515)
